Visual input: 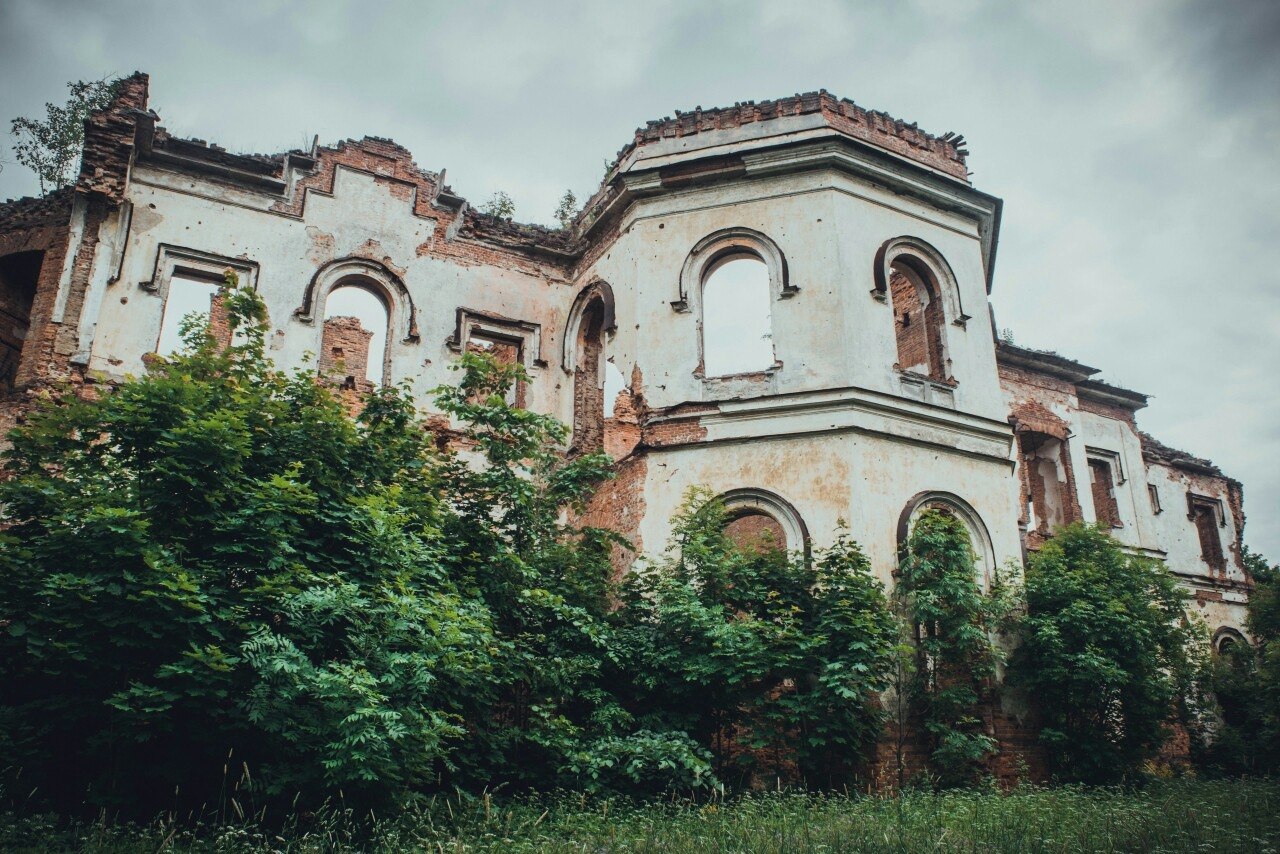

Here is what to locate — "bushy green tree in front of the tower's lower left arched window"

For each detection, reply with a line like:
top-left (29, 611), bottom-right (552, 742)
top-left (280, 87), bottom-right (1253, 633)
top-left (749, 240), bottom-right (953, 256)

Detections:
top-left (626, 490), bottom-right (897, 785)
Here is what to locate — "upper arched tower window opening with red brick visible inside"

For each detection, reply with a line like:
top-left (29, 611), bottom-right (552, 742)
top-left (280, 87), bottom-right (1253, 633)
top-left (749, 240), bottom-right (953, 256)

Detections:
top-left (888, 256), bottom-right (947, 382)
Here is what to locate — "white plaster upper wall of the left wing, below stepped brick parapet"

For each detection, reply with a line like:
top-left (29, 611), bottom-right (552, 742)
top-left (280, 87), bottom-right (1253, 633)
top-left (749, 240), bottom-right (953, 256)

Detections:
top-left (98, 166), bottom-right (573, 411)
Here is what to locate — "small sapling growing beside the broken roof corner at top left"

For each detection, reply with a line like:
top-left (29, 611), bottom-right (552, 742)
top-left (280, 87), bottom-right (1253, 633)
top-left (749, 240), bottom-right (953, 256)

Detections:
top-left (9, 78), bottom-right (120, 195)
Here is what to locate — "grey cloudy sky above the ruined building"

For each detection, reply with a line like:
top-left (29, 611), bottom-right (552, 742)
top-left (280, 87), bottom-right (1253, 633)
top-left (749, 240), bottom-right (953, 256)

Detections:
top-left (0, 0), bottom-right (1280, 560)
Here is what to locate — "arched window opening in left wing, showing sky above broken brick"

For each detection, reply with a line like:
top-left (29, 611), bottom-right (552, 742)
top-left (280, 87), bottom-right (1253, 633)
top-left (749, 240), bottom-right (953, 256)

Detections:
top-left (320, 280), bottom-right (390, 392)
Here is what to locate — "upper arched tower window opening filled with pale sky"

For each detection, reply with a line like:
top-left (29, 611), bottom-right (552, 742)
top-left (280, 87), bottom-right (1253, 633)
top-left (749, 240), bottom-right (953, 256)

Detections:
top-left (703, 252), bottom-right (776, 376)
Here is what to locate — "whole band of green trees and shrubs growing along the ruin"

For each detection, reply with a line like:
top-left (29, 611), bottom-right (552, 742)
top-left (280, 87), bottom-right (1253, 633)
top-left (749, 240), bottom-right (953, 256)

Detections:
top-left (0, 267), bottom-right (1280, 848)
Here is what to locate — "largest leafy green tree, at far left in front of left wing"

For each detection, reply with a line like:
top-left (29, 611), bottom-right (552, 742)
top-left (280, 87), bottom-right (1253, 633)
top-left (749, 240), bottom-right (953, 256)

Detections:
top-left (0, 274), bottom-right (493, 805)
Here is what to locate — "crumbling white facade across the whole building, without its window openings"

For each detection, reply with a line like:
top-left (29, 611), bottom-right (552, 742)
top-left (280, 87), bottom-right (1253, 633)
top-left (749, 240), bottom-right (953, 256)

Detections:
top-left (2, 78), bottom-right (1249, 640)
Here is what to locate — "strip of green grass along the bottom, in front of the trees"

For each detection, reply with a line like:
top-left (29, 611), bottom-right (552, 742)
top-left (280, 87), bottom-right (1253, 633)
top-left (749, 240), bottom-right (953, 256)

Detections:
top-left (0, 780), bottom-right (1280, 854)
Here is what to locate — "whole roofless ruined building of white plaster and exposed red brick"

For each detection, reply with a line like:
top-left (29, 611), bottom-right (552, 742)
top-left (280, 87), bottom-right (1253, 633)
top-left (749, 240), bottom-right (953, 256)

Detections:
top-left (0, 74), bottom-right (1251, 701)
